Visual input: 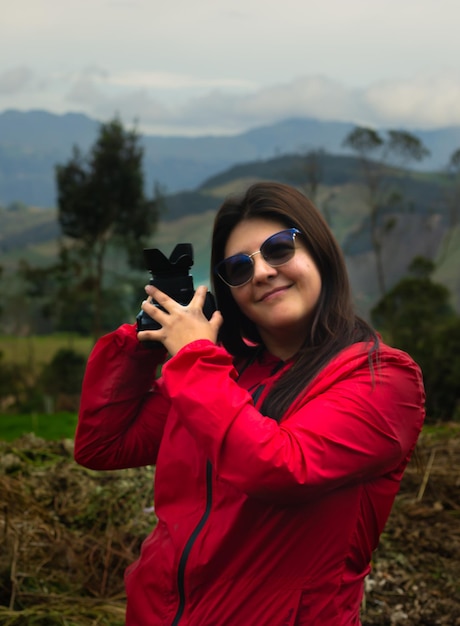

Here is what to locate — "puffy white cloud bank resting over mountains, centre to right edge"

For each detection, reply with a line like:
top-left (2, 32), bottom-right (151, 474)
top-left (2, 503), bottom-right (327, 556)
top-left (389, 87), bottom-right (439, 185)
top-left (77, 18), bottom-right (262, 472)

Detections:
top-left (122, 76), bottom-right (460, 134)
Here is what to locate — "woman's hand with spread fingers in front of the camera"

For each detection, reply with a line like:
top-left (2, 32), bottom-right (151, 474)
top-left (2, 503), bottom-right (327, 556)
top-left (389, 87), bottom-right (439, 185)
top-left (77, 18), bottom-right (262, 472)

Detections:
top-left (137, 285), bottom-right (223, 356)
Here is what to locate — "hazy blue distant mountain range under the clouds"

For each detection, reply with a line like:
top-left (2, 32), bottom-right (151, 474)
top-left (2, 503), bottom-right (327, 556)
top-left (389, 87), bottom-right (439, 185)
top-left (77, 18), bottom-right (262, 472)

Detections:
top-left (0, 110), bottom-right (460, 207)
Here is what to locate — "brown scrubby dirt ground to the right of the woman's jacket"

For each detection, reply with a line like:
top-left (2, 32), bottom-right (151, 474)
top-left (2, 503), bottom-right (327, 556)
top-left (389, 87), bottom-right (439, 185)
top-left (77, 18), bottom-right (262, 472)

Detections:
top-left (362, 424), bottom-right (460, 626)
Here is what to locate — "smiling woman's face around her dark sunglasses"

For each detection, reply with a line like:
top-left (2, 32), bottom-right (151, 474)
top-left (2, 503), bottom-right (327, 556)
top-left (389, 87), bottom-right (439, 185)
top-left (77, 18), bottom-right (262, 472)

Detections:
top-left (225, 218), bottom-right (321, 358)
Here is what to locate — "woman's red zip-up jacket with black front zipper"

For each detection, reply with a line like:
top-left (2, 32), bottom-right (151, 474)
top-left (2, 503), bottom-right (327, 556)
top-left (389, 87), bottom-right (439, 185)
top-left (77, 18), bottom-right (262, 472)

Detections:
top-left (75, 325), bottom-right (424, 626)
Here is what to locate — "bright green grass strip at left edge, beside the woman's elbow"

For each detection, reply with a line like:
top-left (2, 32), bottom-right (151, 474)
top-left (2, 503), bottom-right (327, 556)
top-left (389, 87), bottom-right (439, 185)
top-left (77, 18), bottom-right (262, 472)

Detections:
top-left (0, 413), bottom-right (77, 441)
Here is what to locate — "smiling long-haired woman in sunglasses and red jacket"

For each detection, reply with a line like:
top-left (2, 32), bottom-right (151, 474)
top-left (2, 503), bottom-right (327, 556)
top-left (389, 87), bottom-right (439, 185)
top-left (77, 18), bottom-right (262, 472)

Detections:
top-left (75, 178), bottom-right (424, 626)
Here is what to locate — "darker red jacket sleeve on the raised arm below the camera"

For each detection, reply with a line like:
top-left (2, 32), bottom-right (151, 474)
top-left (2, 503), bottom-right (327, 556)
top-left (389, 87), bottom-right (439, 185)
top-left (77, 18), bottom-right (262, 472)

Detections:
top-left (74, 324), bottom-right (169, 470)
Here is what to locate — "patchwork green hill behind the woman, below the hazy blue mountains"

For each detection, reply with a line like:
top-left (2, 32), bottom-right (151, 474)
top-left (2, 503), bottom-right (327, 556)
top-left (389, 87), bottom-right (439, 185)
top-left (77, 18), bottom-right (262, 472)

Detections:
top-left (0, 153), bottom-right (460, 314)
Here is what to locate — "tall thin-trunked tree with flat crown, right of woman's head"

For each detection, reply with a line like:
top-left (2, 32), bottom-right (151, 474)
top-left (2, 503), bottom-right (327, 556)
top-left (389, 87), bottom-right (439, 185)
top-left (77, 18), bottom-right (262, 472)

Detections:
top-left (343, 126), bottom-right (429, 297)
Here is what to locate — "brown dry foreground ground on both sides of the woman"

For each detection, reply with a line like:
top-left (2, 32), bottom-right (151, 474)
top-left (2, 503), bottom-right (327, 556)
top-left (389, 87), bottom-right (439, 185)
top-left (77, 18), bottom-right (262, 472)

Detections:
top-left (0, 424), bottom-right (460, 626)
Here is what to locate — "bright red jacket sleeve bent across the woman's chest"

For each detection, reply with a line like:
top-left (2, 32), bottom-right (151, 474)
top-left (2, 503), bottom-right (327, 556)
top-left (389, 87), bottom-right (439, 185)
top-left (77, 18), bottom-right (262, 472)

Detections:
top-left (163, 342), bottom-right (424, 502)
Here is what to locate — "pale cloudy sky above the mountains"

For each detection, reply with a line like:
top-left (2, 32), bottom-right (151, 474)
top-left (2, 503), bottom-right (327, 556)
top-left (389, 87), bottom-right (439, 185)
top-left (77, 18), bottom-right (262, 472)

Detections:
top-left (0, 0), bottom-right (460, 136)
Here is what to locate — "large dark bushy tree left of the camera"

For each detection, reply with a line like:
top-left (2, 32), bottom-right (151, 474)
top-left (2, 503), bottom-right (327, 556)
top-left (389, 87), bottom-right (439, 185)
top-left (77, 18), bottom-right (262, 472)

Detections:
top-left (54, 118), bottom-right (160, 338)
